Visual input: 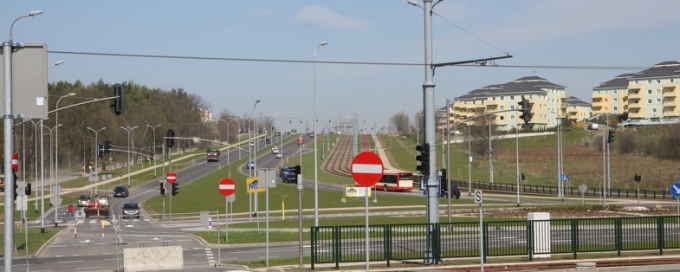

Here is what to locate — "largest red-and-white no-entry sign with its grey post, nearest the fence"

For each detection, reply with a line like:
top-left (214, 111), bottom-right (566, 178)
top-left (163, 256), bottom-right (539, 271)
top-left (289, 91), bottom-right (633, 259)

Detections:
top-left (350, 151), bottom-right (384, 271)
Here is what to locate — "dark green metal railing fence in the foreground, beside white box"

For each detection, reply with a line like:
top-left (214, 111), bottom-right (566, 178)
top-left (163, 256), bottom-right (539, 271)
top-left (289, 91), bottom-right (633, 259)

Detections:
top-left (311, 216), bottom-right (680, 269)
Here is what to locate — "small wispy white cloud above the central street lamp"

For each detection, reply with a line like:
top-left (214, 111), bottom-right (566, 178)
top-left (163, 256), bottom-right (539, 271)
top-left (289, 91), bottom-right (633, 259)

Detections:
top-left (295, 6), bottom-right (366, 30)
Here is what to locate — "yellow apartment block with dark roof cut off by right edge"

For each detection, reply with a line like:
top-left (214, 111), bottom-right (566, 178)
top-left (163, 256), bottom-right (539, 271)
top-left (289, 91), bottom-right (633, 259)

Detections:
top-left (592, 61), bottom-right (680, 123)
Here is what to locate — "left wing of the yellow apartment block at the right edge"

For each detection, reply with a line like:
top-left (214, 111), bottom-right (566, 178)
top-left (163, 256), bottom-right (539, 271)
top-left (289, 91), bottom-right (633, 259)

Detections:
top-left (592, 73), bottom-right (635, 114)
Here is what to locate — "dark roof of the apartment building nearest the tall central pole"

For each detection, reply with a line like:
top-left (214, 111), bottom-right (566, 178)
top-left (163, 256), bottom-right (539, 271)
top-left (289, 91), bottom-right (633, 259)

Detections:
top-left (455, 76), bottom-right (564, 100)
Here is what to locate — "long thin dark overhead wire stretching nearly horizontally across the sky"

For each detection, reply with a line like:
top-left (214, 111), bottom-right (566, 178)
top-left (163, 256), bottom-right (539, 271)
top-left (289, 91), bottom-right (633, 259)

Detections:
top-left (47, 50), bottom-right (649, 71)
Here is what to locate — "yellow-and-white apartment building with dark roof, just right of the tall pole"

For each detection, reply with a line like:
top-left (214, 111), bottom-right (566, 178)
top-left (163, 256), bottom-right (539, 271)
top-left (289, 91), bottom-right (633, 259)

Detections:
top-left (449, 76), bottom-right (569, 131)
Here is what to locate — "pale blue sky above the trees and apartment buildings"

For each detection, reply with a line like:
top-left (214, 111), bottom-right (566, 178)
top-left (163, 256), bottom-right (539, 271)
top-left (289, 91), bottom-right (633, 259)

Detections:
top-left (0, 0), bottom-right (680, 131)
